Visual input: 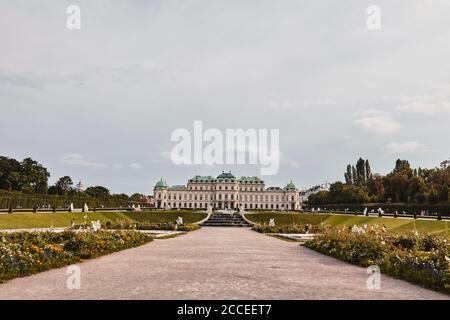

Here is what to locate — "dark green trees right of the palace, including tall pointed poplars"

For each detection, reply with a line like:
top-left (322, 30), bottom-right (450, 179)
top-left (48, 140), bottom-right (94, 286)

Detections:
top-left (308, 158), bottom-right (450, 205)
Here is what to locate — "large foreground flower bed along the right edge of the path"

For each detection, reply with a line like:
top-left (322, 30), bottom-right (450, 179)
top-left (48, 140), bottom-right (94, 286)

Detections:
top-left (305, 227), bottom-right (450, 293)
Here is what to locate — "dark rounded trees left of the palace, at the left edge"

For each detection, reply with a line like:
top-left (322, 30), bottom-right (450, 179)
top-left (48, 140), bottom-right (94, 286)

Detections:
top-left (0, 156), bottom-right (148, 208)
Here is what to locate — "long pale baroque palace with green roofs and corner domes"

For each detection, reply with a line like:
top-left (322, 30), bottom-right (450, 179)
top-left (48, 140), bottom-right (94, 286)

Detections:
top-left (153, 172), bottom-right (300, 210)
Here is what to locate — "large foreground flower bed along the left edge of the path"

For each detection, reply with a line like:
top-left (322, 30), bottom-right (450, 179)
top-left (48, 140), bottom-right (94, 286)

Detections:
top-left (0, 231), bottom-right (152, 282)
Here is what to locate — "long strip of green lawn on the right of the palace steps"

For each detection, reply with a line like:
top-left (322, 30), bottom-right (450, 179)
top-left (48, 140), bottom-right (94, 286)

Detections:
top-left (245, 213), bottom-right (450, 237)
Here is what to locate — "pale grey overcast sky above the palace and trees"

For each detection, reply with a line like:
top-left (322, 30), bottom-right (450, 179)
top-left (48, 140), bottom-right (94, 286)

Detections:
top-left (0, 0), bottom-right (450, 194)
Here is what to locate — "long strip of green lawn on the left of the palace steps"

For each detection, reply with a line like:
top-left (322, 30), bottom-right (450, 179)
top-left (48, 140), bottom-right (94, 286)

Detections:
top-left (0, 210), bottom-right (207, 229)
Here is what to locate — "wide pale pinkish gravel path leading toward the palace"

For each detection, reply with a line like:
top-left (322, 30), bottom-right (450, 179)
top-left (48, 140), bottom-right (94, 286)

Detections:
top-left (0, 227), bottom-right (450, 299)
